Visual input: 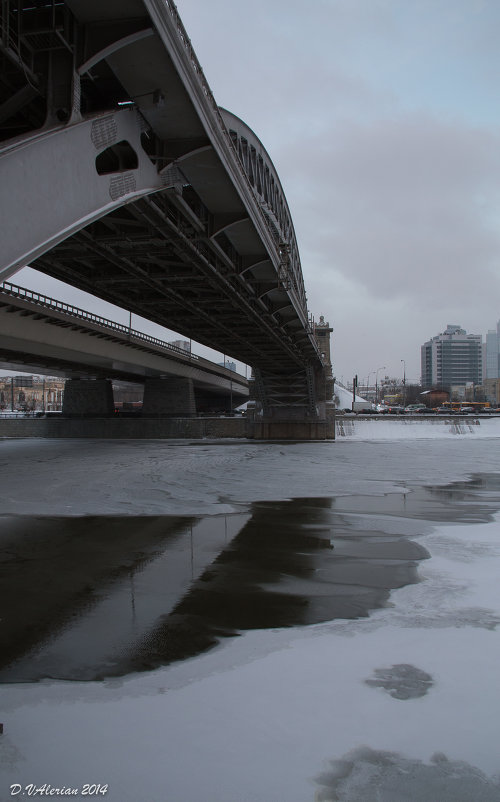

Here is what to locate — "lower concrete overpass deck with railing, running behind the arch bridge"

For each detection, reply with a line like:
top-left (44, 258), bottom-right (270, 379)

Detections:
top-left (0, 282), bottom-right (249, 412)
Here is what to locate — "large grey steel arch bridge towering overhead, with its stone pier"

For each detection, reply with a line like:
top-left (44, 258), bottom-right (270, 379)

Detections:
top-left (0, 0), bottom-right (332, 436)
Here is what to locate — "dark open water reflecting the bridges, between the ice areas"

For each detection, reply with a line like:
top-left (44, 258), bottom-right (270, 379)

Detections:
top-left (0, 474), bottom-right (500, 682)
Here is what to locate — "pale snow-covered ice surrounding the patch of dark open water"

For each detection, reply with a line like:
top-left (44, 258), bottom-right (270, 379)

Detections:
top-left (0, 419), bottom-right (500, 802)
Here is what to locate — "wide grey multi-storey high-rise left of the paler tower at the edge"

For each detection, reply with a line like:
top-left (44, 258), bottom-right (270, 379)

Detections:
top-left (421, 324), bottom-right (483, 388)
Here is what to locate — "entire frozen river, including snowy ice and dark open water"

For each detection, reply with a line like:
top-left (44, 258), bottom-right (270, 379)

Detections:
top-left (0, 419), bottom-right (500, 802)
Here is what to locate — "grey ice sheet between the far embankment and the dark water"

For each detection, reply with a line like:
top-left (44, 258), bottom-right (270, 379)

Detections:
top-left (0, 418), bottom-right (500, 515)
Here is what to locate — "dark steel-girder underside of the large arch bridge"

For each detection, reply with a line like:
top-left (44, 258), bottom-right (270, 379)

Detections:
top-left (31, 192), bottom-right (306, 370)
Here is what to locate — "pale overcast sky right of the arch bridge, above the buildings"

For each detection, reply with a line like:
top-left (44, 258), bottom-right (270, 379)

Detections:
top-left (12, 0), bottom-right (500, 382)
